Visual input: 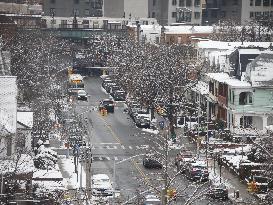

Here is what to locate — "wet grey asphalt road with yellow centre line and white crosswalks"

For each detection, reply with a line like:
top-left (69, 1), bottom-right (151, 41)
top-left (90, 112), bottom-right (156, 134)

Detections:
top-left (68, 77), bottom-right (255, 205)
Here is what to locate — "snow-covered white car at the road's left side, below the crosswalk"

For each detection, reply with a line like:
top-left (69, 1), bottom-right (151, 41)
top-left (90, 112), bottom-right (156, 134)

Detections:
top-left (91, 174), bottom-right (113, 196)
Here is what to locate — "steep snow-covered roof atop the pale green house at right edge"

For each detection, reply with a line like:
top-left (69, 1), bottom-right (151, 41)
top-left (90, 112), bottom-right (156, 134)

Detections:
top-left (246, 50), bottom-right (273, 87)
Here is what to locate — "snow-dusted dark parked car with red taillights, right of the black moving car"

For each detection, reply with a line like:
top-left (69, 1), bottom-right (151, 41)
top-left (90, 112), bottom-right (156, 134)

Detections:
top-left (185, 161), bottom-right (209, 181)
